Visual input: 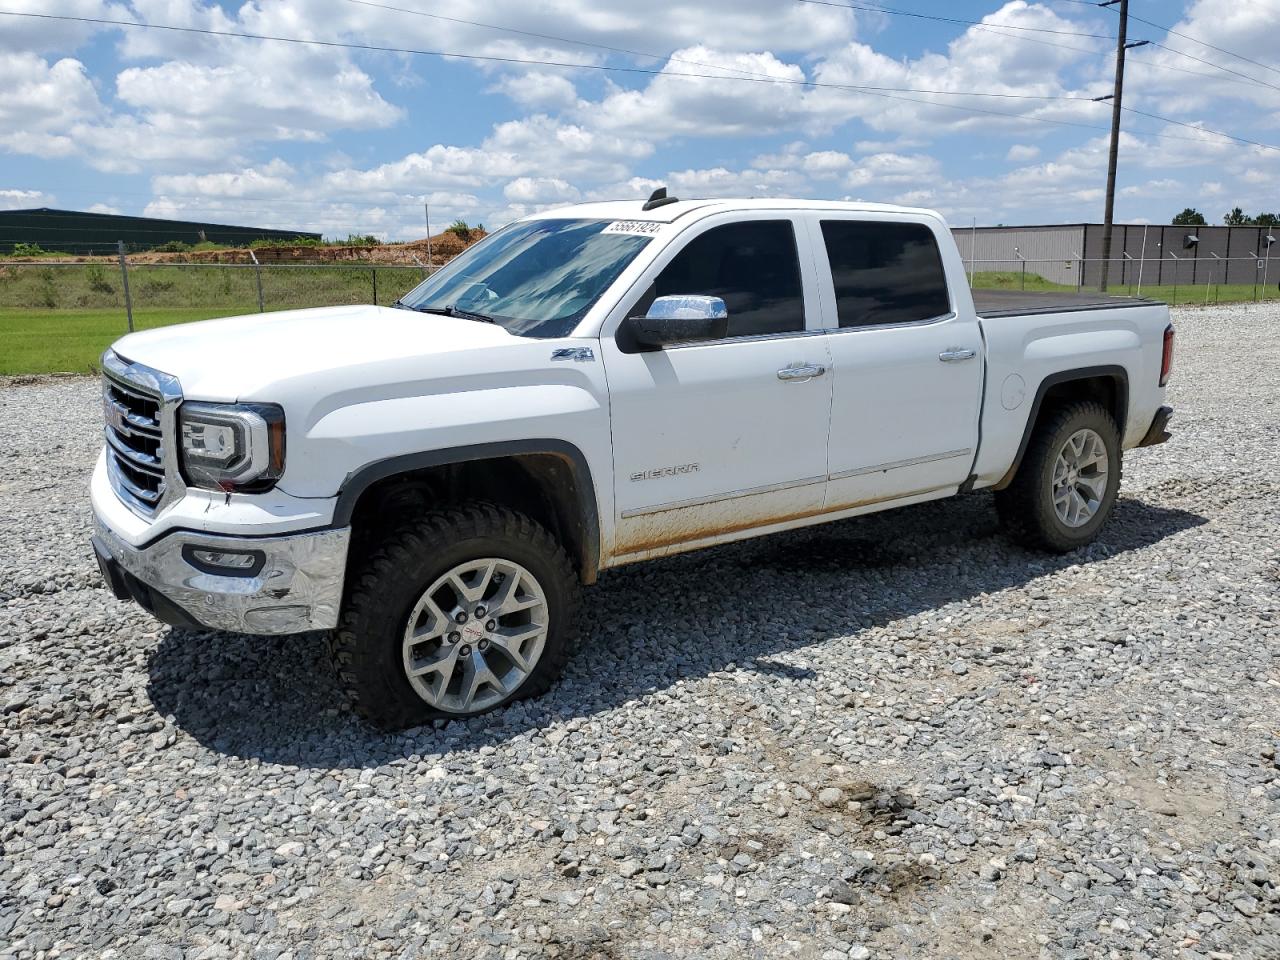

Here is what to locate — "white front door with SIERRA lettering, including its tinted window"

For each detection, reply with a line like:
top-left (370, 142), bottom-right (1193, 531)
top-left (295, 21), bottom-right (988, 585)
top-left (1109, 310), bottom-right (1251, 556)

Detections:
top-left (600, 212), bottom-right (833, 563)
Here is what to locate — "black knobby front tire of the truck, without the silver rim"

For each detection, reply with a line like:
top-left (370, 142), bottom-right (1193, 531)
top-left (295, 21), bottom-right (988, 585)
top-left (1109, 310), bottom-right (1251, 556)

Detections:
top-left (329, 503), bottom-right (580, 730)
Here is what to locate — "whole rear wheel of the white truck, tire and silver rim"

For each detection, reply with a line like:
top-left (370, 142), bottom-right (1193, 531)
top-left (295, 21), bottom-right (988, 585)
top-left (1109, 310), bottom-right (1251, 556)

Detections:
top-left (996, 401), bottom-right (1120, 553)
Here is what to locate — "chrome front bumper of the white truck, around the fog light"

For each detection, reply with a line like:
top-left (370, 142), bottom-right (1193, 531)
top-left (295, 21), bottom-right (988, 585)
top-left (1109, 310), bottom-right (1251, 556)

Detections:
top-left (93, 512), bottom-right (351, 634)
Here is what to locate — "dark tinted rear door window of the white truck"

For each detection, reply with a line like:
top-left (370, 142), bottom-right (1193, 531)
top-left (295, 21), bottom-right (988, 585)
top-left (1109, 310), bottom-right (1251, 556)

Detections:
top-left (822, 220), bottom-right (951, 326)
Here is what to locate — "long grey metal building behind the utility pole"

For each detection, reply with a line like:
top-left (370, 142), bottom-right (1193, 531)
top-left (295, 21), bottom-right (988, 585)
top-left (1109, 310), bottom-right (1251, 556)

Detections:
top-left (952, 223), bottom-right (1280, 287)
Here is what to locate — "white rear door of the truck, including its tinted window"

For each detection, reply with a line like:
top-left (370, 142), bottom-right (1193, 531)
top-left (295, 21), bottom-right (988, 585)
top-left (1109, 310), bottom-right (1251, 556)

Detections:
top-left (809, 212), bottom-right (983, 509)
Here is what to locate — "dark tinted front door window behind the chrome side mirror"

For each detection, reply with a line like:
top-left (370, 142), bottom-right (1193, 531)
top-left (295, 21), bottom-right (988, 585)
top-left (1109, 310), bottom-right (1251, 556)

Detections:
top-left (636, 220), bottom-right (804, 337)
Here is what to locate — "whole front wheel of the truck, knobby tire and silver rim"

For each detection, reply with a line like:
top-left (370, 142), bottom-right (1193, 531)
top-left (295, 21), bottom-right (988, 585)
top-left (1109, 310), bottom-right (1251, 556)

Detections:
top-left (330, 503), bottom-right (579, 728)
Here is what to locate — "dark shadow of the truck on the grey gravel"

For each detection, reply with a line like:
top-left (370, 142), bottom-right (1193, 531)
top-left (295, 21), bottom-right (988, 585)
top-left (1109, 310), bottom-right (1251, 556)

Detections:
top-left (148, 495), bottom-right (1207, 769)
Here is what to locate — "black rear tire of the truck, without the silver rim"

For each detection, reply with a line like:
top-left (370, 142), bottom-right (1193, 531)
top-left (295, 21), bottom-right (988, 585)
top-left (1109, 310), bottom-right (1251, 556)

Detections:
top-left (996, 401), bottom-right (1121, 553)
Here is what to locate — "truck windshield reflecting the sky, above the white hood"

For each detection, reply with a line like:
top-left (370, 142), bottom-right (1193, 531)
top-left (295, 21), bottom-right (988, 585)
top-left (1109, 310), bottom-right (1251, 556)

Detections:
top-left (399, 220), bottom-right (649, 338)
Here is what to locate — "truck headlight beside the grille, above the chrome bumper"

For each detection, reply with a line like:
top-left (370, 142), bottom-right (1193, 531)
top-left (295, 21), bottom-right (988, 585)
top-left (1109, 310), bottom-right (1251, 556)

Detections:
top-left (178, 403), bottom-right (284, 493)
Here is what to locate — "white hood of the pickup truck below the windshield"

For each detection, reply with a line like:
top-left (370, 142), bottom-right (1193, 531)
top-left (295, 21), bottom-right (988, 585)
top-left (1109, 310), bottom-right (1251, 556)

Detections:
top-left (113, 305), bottom-right (525, 402)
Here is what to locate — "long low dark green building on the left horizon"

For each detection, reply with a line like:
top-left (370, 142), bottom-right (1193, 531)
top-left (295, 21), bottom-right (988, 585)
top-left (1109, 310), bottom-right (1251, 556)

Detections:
top-left (0, 207), bottom-right (320, 253)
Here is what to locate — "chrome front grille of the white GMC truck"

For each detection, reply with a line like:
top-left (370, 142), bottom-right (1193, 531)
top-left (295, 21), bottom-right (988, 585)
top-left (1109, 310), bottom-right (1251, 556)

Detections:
top-left (102, 351), bottom-right (182, 516)
